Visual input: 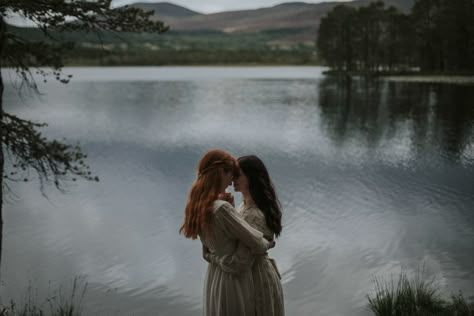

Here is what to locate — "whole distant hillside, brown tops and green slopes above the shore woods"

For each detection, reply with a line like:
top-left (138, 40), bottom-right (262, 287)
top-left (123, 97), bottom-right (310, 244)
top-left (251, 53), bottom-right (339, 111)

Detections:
top-left (7, 0), bottom-right (414, 55)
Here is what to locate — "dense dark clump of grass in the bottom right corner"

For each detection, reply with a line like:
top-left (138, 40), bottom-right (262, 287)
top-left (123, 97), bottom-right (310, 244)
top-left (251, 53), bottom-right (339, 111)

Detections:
top-left (367, 272), bottom-right (474, 316)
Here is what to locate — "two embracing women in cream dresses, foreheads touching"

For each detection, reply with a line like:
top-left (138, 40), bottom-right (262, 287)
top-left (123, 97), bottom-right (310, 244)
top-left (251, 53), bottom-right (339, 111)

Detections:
top-left (180, 150), bottom-right (284, 316)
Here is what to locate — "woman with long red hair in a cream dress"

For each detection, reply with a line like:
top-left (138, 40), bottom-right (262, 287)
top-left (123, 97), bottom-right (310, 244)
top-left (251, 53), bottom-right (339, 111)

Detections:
top-left (180, 150), bottom-right (273, 316)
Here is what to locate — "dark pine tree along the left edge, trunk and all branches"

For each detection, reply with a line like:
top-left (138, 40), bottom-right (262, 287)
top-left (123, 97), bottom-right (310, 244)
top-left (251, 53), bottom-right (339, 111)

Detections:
top-left (0, 0), bottom-right (168, 270)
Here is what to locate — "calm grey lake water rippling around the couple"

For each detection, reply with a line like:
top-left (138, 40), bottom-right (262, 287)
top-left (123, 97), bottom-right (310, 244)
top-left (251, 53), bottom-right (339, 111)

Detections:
top-left (0, 67), bottom-right (474, 316)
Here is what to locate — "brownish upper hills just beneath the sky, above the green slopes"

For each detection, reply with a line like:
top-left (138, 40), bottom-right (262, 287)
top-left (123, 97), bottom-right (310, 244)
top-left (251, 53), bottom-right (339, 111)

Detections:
top-left (132, 0), bottom-right (414, 46)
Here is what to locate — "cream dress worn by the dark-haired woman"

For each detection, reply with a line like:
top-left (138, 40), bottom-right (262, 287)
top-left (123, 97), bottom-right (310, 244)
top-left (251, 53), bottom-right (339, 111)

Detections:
top-left (205, 203), bottom-right (285, 316)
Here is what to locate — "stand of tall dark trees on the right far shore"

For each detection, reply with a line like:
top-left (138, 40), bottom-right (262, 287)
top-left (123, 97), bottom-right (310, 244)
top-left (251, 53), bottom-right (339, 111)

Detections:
top-left (316, 0), bottom-right (474, 74)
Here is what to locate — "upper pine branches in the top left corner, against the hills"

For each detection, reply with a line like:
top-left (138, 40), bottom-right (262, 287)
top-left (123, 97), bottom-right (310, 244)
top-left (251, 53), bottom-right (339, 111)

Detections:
top-left (0, 0), bottom-right (168, 86)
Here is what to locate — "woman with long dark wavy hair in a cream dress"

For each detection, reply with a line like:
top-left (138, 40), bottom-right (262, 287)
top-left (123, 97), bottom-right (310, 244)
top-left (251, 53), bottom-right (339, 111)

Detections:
top-left (205, 155), bottom-right (285, 316)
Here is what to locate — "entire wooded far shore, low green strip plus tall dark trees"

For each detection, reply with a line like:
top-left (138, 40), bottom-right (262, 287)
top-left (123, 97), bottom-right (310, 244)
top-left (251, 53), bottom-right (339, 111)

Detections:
top-left (4, 0), bottom-right (474, 72)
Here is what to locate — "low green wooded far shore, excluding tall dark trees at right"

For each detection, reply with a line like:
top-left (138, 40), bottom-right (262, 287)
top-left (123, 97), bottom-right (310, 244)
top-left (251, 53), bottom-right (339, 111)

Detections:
top-left (9, 26), bottom-right (320, 66)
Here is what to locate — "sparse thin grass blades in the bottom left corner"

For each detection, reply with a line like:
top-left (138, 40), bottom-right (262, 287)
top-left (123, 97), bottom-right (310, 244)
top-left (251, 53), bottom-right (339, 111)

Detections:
top-left (0, 277), bottom-right (87, 316)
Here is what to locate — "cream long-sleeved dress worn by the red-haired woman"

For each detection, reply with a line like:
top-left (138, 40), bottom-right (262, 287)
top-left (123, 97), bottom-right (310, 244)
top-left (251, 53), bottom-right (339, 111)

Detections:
top-left (199, 200), bottom-right (269, 316)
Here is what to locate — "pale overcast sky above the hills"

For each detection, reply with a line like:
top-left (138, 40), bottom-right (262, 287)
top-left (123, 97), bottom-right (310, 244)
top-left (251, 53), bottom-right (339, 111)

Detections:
top-left (114, 0), bottom-right (350, 13)
